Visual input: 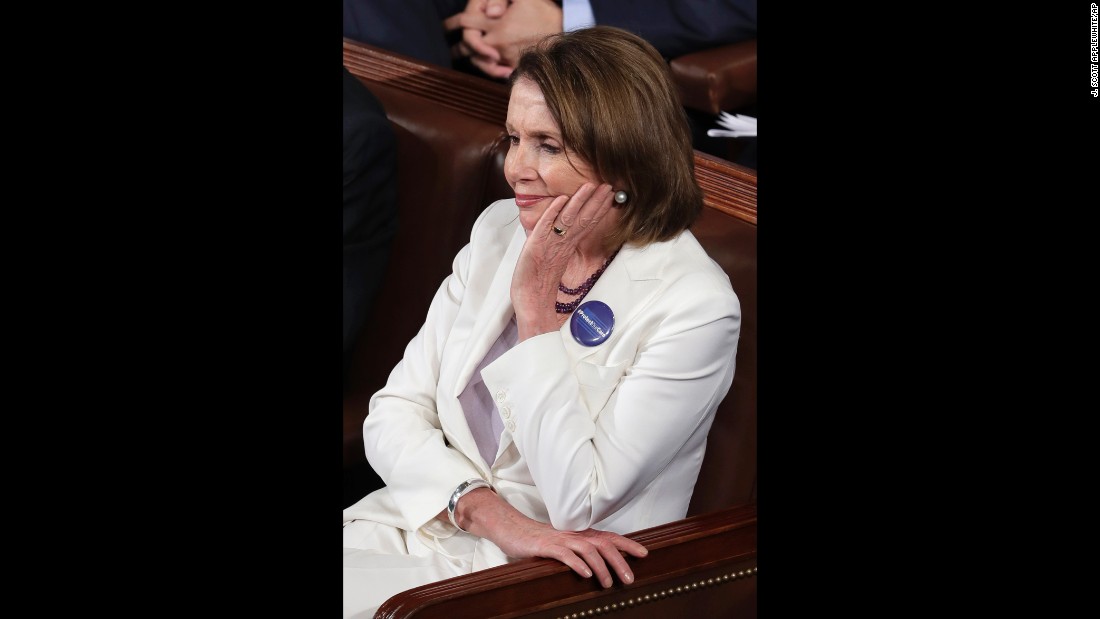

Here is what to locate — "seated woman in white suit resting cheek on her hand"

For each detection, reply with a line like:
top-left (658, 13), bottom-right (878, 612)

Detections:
top-left (343, 26), bottom-right (740, 617)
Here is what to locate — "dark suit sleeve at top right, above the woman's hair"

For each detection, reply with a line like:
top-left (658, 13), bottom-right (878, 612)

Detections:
top-left (591, 0), bottom-right (757, 58)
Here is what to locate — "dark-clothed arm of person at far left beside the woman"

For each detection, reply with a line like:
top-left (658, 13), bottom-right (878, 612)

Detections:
top-left (343, 68), bottom-right (397, 363)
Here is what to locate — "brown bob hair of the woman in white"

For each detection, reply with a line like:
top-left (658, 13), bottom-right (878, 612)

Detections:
top-left (509, 25), bottom-right (703, 247)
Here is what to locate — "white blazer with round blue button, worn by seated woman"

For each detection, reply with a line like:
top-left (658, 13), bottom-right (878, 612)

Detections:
top-left (343, 199), bottom-right (740, 565)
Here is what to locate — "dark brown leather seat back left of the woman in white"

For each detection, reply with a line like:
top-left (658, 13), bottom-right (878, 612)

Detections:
top-left (343, 40), bottom-right (515, 499)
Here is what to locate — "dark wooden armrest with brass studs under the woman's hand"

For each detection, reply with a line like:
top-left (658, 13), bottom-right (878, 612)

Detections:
top-left (375, 504), bottom-right (757, 619)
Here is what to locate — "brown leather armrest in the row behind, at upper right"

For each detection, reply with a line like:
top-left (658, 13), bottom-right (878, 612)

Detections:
top-left (669, 38), bottom-right (756, 114)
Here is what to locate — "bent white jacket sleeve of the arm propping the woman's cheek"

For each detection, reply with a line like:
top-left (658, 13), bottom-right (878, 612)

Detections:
top-left (482, 273), bottom-right (740, 530)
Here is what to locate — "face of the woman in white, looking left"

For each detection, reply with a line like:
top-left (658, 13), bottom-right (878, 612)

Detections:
top-left (504, 78), bottom-right (598, 234)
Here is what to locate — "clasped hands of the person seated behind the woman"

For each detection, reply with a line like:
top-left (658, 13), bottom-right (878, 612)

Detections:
top-left (443, 0), bottom-right (562, 79)
